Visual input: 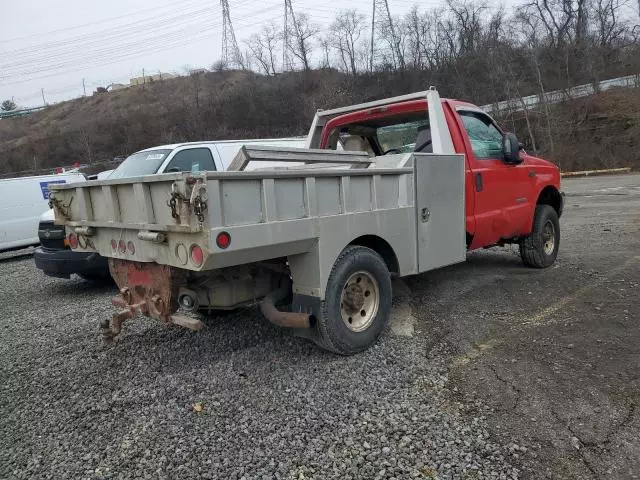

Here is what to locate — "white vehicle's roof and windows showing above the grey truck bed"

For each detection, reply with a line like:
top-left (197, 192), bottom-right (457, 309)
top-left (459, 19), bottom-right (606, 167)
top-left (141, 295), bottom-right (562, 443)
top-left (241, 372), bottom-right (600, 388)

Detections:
top-left (109, 137), bottom-right (307, 180)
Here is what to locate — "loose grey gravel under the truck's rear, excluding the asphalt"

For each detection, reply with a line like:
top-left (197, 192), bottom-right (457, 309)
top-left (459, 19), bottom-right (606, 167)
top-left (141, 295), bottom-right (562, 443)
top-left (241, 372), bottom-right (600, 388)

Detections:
top-left (0, 254), bottom-right (518, 479)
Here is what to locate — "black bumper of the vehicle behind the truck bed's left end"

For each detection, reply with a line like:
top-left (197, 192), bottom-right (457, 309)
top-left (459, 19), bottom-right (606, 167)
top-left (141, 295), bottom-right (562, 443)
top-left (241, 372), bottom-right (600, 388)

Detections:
top-left (33, 247), bottom-right (109, 278)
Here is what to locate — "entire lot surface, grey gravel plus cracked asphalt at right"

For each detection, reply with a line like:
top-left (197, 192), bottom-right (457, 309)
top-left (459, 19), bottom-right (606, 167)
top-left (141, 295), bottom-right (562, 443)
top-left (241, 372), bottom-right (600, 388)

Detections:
top-left (0, 175), bottom-right (640, 479)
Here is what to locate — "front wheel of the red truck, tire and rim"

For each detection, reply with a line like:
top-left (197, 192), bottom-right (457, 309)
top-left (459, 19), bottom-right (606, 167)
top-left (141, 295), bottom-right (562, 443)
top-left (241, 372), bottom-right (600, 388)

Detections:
top-left (520, 205), bottom-right (560, 268)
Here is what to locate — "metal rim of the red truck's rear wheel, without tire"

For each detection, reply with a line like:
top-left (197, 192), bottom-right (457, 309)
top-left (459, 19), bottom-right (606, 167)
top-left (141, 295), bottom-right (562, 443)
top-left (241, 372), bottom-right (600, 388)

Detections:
top-left (340, 271), bottom-right (380, 332)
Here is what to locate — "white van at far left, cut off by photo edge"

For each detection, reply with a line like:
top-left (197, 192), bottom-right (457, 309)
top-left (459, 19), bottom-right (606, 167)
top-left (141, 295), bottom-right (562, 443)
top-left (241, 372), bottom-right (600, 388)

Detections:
top-left (0, 173), bottom-right (85, 251)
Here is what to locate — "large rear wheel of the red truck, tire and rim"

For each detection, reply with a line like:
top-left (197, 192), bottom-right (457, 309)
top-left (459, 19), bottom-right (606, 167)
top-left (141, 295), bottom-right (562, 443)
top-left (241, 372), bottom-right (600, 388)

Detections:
top-left (316, 246), bottom-right (392, 355)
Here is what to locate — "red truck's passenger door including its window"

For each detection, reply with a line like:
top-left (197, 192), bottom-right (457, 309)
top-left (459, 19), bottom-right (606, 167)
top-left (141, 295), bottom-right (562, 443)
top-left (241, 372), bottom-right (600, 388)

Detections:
top-left (457, 108), bottom-right (535, 248)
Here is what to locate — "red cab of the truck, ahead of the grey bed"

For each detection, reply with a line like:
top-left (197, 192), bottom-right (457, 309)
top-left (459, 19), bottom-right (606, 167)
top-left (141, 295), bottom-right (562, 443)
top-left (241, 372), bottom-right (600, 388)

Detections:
top-left (310, 95), bottom-right (563, 256)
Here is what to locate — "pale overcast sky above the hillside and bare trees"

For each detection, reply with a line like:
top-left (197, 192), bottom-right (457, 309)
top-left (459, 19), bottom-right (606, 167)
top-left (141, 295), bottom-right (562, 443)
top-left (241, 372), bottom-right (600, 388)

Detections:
top-left (0, 0), bottom-right (636, 106)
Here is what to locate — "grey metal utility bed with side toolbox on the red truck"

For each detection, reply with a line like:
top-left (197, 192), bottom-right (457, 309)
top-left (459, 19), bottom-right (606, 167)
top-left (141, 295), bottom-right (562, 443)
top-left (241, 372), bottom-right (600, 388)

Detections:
top-left (52, 147), bottom-right (466, 297)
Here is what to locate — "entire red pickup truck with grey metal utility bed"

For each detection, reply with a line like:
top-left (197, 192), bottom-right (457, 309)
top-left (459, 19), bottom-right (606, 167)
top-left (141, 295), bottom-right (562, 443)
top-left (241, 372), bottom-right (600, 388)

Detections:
top-left (52, 90), bottom-right (563, 354)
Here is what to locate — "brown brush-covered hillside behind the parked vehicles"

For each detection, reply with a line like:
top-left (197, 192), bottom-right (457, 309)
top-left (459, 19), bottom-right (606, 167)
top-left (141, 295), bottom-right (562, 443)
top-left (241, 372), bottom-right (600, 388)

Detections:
top-left (0, 69), bottom-right (640, 173)
